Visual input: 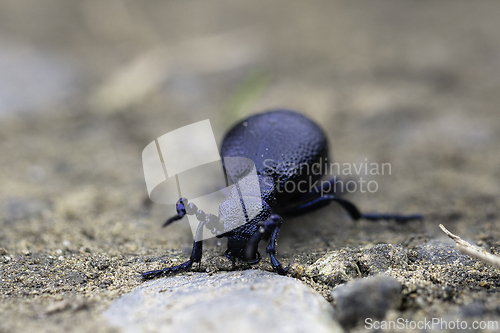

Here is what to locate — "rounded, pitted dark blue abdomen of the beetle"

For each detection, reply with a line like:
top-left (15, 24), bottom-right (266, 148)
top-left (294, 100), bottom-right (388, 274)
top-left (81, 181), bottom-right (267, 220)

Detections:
top-left (221, 110), bottom-right (328, 198)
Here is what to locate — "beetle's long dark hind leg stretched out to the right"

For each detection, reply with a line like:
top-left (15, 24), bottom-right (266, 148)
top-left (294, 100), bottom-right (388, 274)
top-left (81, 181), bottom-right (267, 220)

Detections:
top-left (286, 195), bottom-right (423, 222)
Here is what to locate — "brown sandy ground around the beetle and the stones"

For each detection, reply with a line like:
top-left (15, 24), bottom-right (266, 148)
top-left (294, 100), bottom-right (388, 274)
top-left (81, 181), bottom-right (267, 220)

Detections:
top-left (0, 0), bottom-right (500, 332)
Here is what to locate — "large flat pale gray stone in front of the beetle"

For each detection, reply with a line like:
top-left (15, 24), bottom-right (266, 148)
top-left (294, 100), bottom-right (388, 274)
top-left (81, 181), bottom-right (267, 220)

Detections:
top-left (103, 270), bottom-right (342, 333)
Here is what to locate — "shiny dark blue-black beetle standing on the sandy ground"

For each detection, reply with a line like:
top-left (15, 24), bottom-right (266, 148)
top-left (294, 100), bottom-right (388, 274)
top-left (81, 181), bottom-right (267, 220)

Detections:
top-left (142, 109), bottom-right (422, 280)
